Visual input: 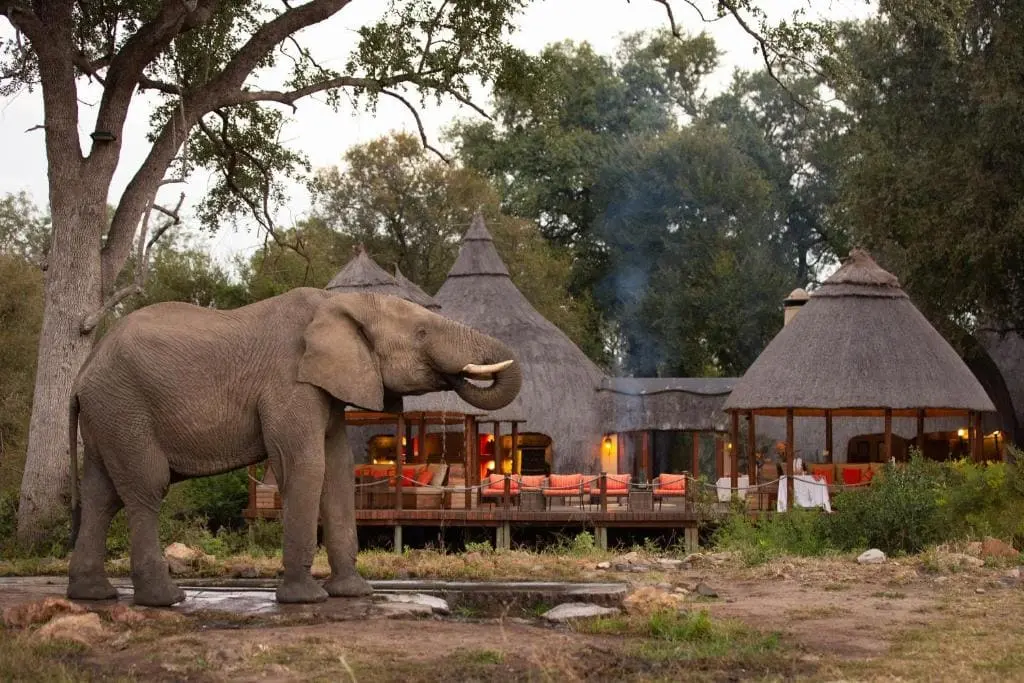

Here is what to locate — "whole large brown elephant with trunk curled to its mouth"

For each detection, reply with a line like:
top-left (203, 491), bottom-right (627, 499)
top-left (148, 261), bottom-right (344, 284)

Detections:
top-left (68, 288), bottom-right (522, 606)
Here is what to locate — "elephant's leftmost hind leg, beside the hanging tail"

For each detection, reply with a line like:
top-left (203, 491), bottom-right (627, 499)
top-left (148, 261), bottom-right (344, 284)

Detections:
top-left (68, 444), bottom-right (122, 600)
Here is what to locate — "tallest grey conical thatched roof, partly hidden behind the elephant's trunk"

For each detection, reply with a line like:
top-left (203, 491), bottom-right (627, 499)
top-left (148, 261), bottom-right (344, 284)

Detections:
top-left (406, 214), bottom-right (603, 471)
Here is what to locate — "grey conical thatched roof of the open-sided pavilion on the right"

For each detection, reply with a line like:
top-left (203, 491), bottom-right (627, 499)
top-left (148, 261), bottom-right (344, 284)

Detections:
top-left (725, 250), bottom-right (995, 412)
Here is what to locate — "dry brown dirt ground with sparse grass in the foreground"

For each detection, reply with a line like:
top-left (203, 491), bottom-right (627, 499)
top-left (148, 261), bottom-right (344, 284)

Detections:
top-left (0, 558), bottom-right (1024, 681)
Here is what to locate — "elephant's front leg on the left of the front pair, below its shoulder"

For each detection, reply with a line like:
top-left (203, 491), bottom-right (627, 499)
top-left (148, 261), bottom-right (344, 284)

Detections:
top-left (276, 458), bottom-right (328, 603)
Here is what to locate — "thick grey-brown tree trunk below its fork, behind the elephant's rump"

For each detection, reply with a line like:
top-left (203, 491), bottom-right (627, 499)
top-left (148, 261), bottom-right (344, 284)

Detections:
top-left (17, 196), bottom-right (106, 545)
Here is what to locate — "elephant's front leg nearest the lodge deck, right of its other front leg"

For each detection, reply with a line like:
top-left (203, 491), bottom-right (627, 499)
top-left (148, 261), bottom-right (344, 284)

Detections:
top-left (321, 423), bottom-right (374, 598)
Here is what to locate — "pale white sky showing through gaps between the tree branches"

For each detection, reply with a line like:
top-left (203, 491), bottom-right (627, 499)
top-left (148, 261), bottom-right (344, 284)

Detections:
top-left (0, 0), bottom-right (874, 264)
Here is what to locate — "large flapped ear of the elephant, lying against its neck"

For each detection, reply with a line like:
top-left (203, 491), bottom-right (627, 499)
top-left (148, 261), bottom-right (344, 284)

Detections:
top-left (299, 298), bottom-right (384, 411)
